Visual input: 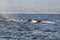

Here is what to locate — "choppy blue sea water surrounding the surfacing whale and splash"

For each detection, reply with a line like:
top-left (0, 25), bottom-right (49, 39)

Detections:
top-left (0, 14), bottom-right (60, 40)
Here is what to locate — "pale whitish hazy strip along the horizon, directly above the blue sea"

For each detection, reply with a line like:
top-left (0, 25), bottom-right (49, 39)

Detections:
top-left (0, 12), bottom-right (60, 14)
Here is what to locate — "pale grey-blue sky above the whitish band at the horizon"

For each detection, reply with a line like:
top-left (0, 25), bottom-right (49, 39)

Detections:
top-left (0, 0), bottom-right (60, 12)
